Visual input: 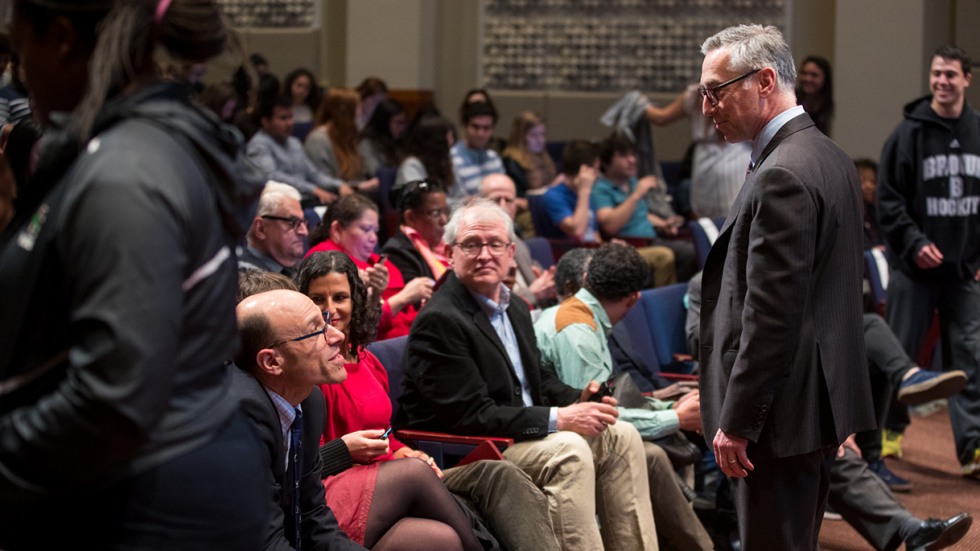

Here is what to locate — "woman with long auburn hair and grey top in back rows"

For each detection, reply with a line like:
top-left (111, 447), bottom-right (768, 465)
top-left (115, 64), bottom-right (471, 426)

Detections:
top-left (303, 88), bottom-right (378, 196)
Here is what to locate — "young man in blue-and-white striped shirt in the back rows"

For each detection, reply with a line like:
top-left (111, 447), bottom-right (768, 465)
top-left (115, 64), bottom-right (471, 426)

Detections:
top-left (449, 102), bottom-right (504, 207)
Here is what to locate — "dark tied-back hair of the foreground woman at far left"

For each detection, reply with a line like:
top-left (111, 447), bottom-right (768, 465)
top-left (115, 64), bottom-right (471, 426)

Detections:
top-left (15, 0), bottom-right (245, 143)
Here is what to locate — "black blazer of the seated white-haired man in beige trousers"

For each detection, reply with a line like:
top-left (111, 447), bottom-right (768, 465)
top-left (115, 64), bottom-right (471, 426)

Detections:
top-left (396, 274), bottom-right (581, 440)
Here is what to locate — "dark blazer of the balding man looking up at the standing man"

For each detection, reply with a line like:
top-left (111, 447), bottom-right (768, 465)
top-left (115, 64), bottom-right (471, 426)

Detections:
top-left (231, 367), bottom-right (364, 551)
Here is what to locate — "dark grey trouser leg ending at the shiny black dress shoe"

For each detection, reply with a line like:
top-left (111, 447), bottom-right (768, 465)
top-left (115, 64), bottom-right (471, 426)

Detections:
top-left (827, 450), bottom-right (912, 551)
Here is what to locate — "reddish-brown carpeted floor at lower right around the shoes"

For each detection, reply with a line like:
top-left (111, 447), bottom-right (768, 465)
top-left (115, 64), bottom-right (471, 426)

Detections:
top-left (820, 408), bottom-right (980, 551)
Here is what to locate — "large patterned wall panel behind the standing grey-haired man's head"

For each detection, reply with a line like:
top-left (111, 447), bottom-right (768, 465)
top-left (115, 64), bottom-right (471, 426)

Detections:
top-left (483, 0), bottom-right (788, 92)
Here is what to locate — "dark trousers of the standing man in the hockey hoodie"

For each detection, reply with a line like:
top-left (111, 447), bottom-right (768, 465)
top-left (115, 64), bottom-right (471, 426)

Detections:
top-left (887, 270), bottom-right (980, 464)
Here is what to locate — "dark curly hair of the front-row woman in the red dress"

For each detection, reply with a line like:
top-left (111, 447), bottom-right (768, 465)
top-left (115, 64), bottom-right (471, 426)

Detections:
top-left (296, 251), bottom-right (381, 356)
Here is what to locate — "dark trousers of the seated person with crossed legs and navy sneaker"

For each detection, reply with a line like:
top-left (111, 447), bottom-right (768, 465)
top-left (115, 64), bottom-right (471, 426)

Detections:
top-left (855, 314), bottom-right (916, 462)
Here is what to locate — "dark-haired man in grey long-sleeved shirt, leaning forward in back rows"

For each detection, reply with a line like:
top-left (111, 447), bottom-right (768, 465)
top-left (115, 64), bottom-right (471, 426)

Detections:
top-left (247, 96), bottom-right (353, 203)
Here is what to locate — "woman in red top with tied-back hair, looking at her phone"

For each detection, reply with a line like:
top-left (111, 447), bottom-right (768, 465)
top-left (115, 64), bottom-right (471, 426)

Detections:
top-left (307, 194), bottom-right (435, 339)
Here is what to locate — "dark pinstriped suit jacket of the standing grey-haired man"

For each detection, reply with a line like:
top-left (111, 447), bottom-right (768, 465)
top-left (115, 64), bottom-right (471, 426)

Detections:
top-left (700, 114), bottom-right (874, 457)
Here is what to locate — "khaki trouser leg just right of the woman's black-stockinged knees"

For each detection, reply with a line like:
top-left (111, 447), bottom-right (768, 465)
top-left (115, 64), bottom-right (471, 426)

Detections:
top-left (442, 461), bottom-right (559, 551)
